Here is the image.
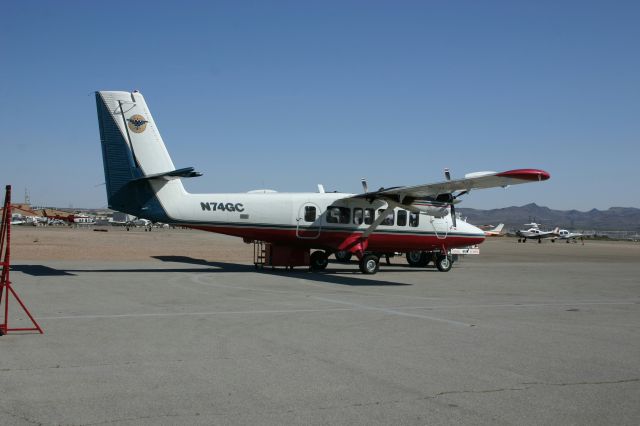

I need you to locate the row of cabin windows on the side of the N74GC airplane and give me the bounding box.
[304,206,420,228]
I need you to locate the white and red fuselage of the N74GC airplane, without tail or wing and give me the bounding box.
[149,181,485,252]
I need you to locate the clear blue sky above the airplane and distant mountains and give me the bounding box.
[0,0,640,210]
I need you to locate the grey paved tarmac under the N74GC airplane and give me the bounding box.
[0,241,640,425]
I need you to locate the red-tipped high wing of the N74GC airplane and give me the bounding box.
[353,169,550,203]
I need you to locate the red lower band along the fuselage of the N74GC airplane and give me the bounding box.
[186,225,485,252]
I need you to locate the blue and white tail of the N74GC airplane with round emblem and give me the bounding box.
[96,91,192,222]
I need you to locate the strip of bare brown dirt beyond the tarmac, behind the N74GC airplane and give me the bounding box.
[6,226,640,264]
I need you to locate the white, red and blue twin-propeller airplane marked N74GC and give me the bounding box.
[96,91,549,274]
